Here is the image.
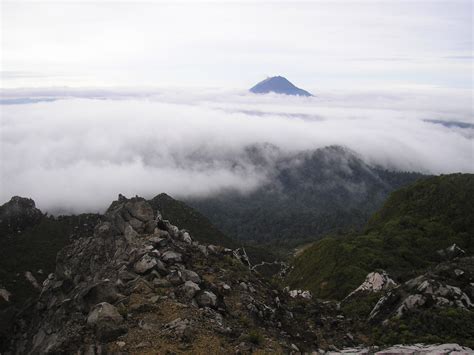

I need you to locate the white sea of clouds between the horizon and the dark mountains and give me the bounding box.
[0,88,474,212]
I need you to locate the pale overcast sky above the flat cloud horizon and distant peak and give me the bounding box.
[1,0,473,91]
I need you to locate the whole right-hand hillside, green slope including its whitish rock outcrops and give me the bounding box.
[286,174,474,351]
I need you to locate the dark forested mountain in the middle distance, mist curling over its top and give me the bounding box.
[184,146,422,245]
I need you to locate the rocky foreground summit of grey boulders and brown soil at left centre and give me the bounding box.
[7,196,356,354]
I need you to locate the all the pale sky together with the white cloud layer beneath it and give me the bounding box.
[0,0,474,212]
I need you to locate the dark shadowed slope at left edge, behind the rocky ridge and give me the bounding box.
[0,197,100,310]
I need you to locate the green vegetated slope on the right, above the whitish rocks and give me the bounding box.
[287,174,474,299]
